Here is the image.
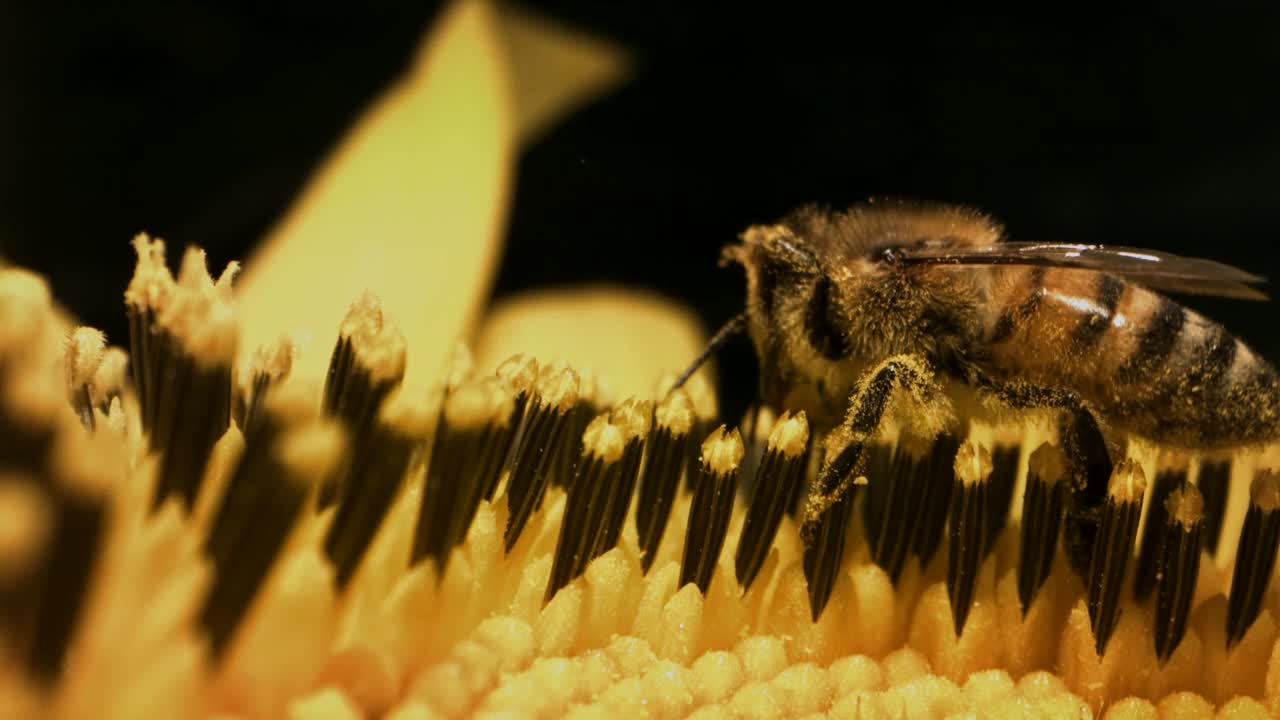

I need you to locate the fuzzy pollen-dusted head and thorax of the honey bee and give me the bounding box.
[722,204,992,415]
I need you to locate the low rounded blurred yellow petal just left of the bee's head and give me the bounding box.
[476,286,708,400]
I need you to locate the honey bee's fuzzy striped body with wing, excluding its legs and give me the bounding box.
[713,201,1280,450]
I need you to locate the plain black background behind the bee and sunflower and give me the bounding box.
[0,1,1280,420]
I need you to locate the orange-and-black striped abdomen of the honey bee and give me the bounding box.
[987,268,1280,448]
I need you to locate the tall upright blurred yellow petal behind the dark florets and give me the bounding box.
[239,0,515,386]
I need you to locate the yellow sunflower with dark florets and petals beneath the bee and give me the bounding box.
[0,0,1280,720]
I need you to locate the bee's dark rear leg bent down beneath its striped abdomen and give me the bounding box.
[980,380,1112,578]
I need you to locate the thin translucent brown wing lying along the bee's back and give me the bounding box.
[901,242,1267,300]
